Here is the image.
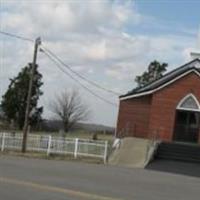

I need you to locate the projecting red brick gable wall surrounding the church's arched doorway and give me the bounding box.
[149,73,200,141]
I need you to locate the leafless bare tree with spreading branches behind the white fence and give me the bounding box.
[50,89,90,132]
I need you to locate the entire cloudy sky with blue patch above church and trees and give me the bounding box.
[0,0,200,126]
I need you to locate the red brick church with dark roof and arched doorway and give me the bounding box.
[117,59,200,143]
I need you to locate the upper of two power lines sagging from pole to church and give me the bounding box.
[43,46,120,96]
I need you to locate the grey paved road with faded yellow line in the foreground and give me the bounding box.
[0,156,200,200]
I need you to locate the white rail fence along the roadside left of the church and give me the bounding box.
[0,133,108,163]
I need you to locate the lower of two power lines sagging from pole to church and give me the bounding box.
[41,49,117,107]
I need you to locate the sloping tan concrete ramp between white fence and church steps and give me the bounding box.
[108,137,150,168]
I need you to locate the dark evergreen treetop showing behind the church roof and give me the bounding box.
[135,60,168,87]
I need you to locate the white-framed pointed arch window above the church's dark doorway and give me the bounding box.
[177,94,200,111]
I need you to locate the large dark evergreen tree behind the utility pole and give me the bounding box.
[1,64,43,129]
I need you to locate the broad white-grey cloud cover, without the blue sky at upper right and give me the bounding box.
[0,0,197,125]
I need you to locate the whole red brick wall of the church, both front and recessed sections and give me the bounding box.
[117,73,200,141]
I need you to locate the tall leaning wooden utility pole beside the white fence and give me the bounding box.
[22,37,41,153]
